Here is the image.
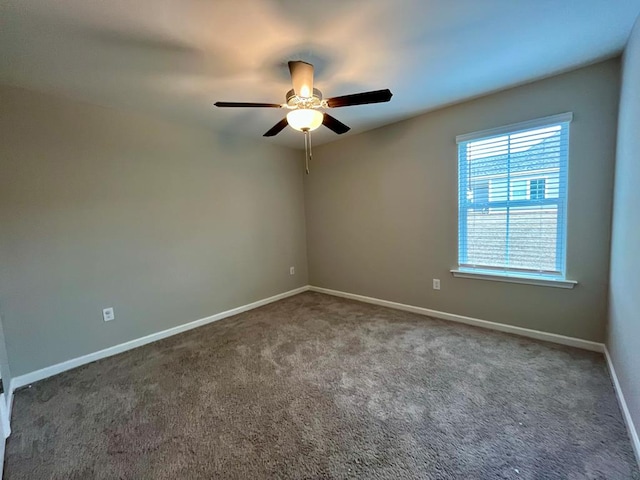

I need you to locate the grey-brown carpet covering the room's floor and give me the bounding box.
[5,293,640,480]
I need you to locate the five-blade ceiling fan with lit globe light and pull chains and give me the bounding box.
[214,61,393,173]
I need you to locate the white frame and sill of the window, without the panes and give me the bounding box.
[451,112,577,288]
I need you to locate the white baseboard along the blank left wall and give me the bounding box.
[9,285,309,396]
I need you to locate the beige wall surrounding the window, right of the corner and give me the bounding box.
[305,59,619,341]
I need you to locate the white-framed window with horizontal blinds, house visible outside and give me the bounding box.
[454,113,575,283]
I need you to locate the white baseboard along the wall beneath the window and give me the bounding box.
[309,286,604,353]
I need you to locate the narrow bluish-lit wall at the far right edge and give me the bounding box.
[607,19,640,454]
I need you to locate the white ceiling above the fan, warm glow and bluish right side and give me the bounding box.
[0,0,640,148]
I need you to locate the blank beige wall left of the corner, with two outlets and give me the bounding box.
[0,87,307,375]
